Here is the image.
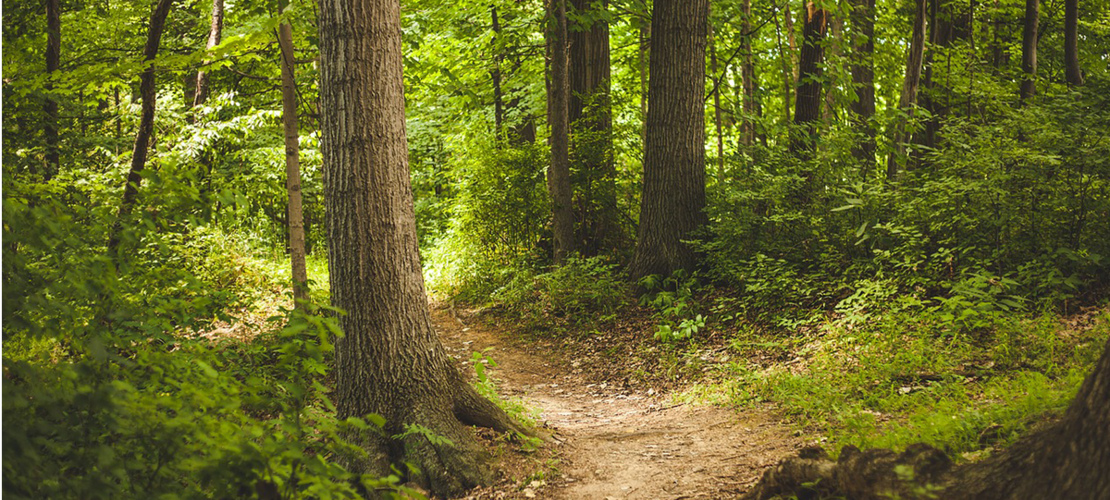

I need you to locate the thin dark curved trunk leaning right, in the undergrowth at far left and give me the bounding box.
[108,0,173,262]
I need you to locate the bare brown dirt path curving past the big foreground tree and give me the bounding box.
[433,308,800,500]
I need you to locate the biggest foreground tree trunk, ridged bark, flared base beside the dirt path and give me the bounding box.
[320,0,516,496]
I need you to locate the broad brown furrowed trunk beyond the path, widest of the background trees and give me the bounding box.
[628,0,709,279]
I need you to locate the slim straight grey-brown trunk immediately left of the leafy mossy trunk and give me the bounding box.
[547,0,575,264]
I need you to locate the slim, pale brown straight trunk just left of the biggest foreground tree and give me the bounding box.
[278,20,309,310]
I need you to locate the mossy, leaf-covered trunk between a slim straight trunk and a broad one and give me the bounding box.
[567,0,617,256]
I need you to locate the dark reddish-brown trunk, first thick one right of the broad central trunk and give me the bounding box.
[790,1,828,157]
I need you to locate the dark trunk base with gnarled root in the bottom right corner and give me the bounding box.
[744,342,1110,500]
